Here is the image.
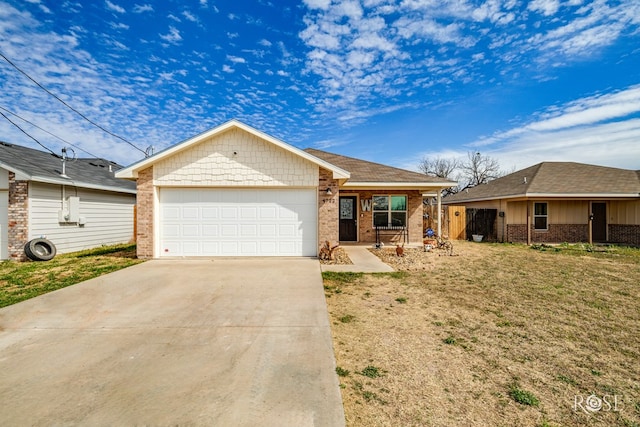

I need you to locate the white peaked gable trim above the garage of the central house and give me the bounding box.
[116,119,349,180]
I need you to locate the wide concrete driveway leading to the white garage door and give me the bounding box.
[0,258,344,426]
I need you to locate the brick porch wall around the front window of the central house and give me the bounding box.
[350,190,424,244]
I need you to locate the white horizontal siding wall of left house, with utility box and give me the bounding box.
[29,182,135,253]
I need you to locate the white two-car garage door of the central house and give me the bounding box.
[160,188,318,256]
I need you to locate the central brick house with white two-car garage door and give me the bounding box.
[116,120,456,258]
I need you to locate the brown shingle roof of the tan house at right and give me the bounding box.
[443,162,640,203]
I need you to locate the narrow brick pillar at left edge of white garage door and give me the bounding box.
[136,167,154,259]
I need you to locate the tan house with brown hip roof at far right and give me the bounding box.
[443,162,640,245]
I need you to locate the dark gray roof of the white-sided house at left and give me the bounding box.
[0,142,136,194]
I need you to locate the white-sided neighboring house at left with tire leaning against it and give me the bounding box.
[0,142,136,260]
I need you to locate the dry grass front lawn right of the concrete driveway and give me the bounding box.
[325,242,640,426]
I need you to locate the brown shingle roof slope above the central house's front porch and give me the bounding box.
[304,148,450,184]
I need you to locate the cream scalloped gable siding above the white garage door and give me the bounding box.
[153,129,318,187]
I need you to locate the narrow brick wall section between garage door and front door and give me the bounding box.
[318,168,339,245]
